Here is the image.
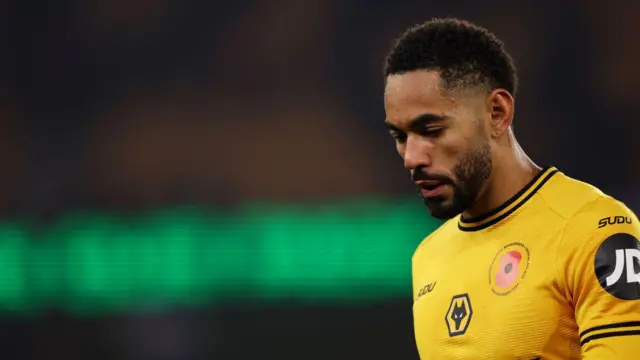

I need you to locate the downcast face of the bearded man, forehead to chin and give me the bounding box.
[384,70,492,219]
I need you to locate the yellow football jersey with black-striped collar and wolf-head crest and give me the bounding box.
[413,167,640,360]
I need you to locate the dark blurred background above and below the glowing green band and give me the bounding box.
[0,0,640,360]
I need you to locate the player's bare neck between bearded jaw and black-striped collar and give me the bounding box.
[462,138,541,219]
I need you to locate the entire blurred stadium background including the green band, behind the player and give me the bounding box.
[0,0,640,360]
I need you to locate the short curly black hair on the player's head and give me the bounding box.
[384,18,518,97]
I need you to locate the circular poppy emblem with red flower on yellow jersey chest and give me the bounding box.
[489,243,529,296]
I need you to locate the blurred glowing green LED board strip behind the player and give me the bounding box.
[0,200,439,312]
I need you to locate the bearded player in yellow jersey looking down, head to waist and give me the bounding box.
[384,19,640,360]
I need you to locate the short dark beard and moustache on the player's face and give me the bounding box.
[419,142,492,220]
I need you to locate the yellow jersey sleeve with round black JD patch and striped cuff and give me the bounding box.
[558,197,640,360]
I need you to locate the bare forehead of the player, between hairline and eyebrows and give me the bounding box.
[384,70,460,125]
